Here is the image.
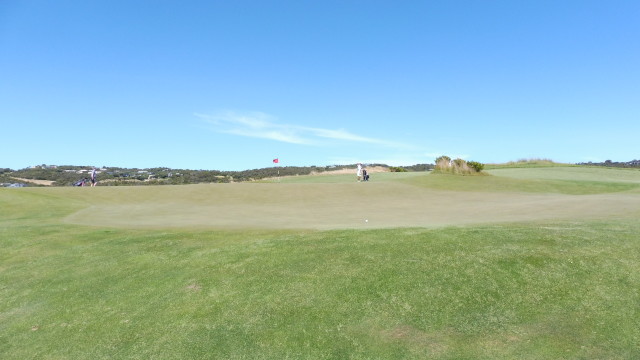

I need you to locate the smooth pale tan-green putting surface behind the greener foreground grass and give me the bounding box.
[58,168,640,230]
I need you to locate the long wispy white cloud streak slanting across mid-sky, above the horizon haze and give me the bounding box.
[195,111,408,148]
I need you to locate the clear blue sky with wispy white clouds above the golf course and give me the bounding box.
[0,0,640,170]
